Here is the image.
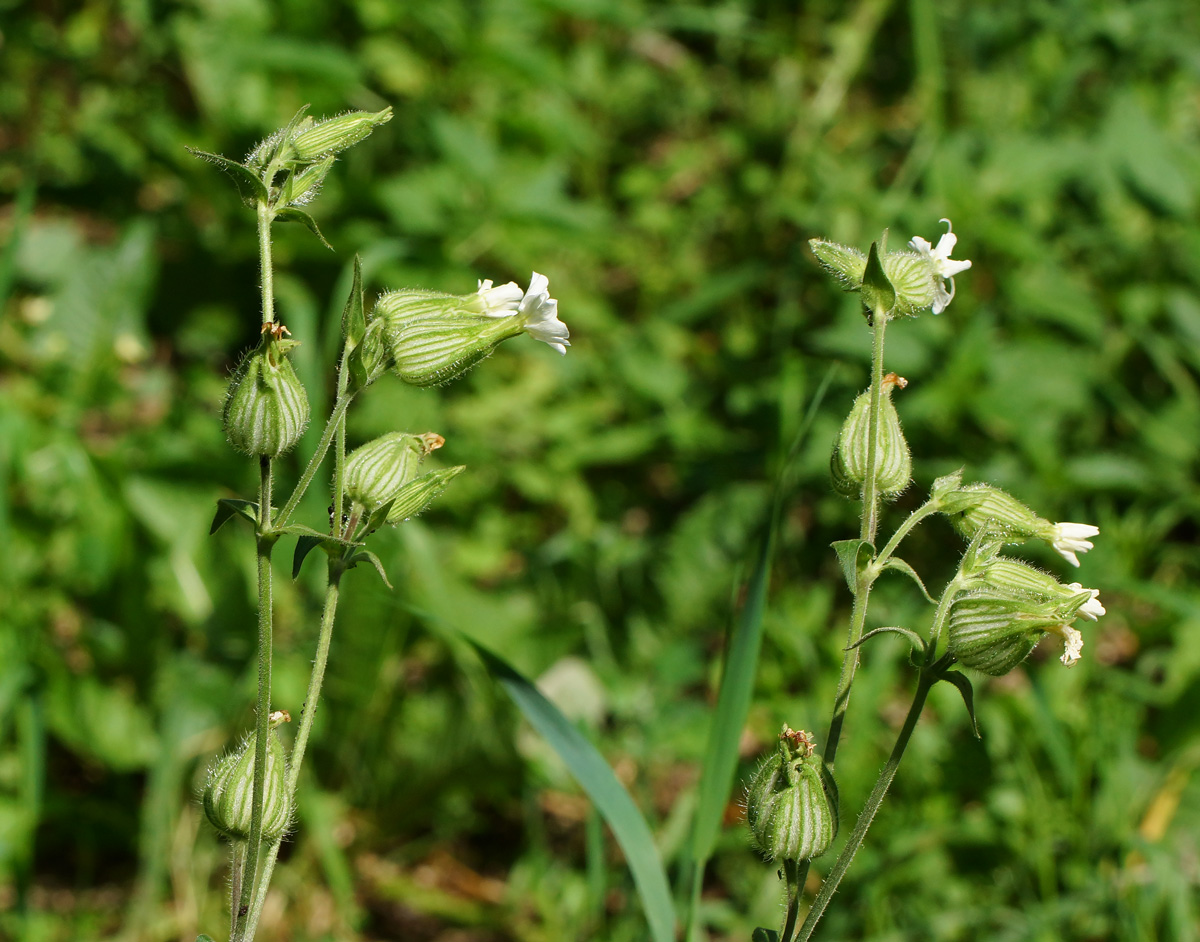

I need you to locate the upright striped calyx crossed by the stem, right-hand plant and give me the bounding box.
[829,373,912,498]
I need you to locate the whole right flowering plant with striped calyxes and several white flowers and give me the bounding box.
[746,220,1104,942]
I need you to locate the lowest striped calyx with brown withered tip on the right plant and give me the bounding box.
[746,725,838,860]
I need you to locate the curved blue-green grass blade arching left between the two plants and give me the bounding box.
[468,638,676,942]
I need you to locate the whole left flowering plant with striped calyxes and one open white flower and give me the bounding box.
[193,108,570,942]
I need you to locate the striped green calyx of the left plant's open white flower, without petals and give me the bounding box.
[374,286,524,386]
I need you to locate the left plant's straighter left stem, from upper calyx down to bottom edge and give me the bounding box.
[234,455,277,938]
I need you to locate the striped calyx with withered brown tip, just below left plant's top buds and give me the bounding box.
[221,325,308,458]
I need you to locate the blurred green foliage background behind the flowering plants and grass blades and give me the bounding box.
[0,0,1200,942]
